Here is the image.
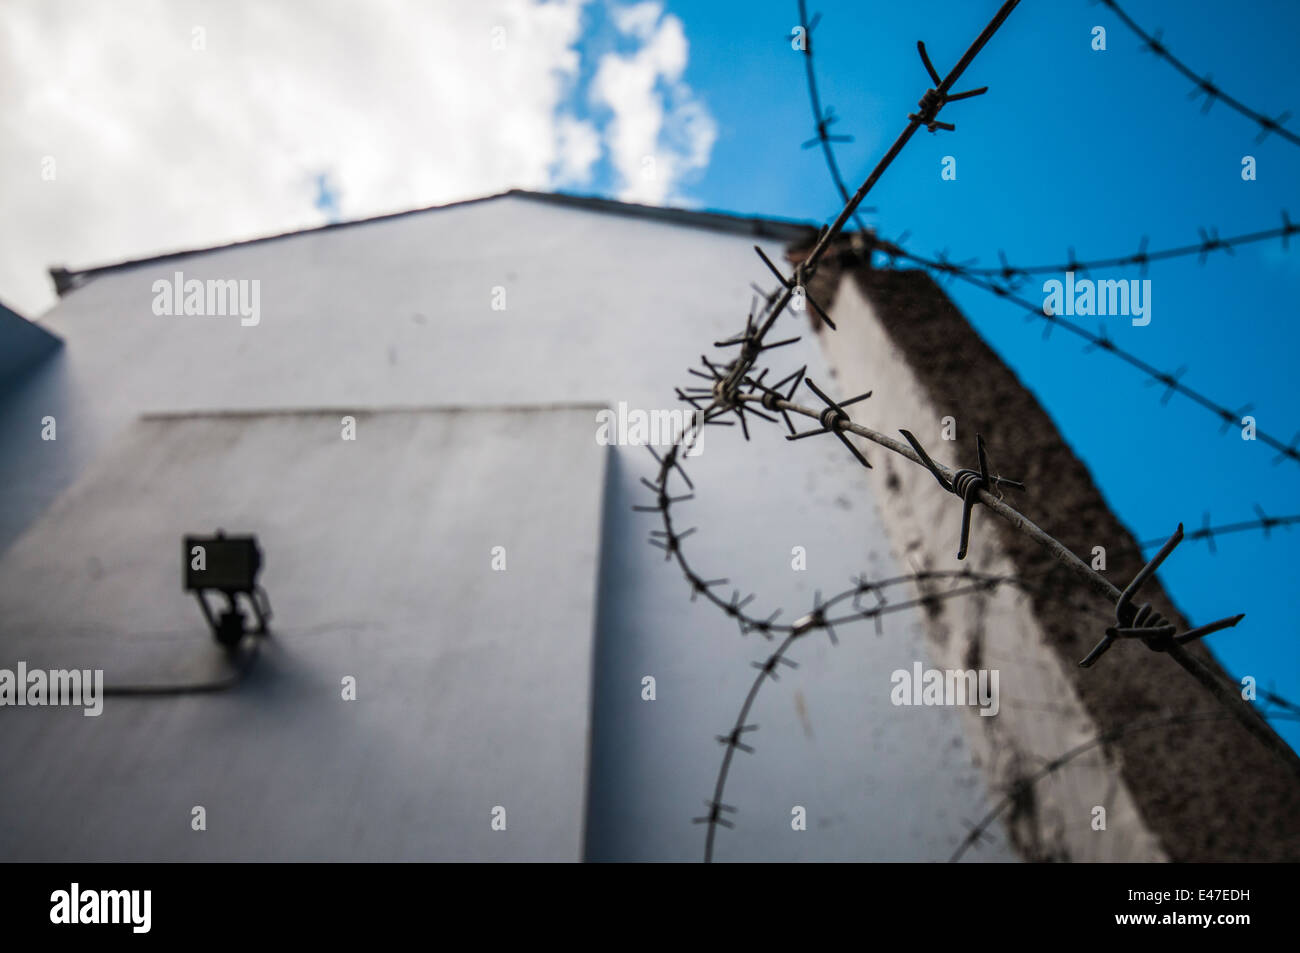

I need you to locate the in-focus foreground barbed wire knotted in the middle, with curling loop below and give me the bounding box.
[647,0,1300,844]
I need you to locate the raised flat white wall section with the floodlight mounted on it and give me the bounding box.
[0,408,605,861]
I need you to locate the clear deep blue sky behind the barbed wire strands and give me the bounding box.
[626,0,1300,746]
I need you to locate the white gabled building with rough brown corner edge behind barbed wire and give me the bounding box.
[0,191,1300,861]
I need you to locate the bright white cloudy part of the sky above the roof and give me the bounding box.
[0,0,715,317]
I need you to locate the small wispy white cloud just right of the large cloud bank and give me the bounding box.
[592,0,718,204]
